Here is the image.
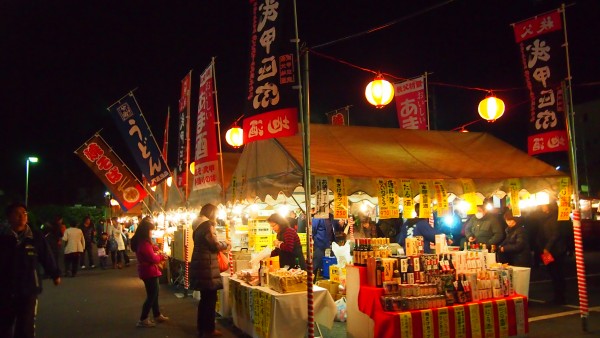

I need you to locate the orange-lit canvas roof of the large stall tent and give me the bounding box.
[226,124,566,199]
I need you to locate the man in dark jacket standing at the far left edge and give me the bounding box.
[0,203,60,338]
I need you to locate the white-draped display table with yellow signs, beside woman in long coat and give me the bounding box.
[223,277,336,338]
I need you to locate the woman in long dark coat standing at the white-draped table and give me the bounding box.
[190,204,231,337]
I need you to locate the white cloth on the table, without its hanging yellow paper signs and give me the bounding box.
[223,277,336,338]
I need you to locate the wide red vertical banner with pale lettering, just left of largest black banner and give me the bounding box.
[193,63,219,190]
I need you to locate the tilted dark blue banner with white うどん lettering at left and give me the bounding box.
[108,93,169,186]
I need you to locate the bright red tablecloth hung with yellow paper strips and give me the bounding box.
[358,268,529,338]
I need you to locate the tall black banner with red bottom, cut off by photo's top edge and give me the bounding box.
[243,0,298,144]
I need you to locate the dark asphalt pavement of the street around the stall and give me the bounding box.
[37,252,600,338]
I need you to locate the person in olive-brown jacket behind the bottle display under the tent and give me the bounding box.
[465,205,504,249]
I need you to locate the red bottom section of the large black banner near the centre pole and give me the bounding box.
[243,108,298,144]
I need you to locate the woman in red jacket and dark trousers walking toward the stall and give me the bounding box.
[131,217,169,327]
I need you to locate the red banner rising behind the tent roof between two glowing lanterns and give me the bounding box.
[394,76,429,130]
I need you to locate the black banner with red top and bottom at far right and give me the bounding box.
[513,10,569,155]
